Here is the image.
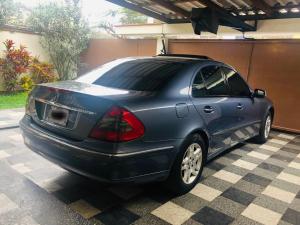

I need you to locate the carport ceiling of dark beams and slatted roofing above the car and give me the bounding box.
[107,0,300,23]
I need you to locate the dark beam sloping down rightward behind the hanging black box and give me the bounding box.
[197,0,256,31]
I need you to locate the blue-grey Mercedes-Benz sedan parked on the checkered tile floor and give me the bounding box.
[20,55,274,193]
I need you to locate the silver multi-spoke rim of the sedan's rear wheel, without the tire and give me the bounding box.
[181,143,202,184]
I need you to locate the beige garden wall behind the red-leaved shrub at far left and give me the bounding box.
[0,30,49,91]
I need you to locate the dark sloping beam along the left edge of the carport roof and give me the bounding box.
[106,0,171,23]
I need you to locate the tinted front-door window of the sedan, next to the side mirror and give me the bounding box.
[222,67,250,97]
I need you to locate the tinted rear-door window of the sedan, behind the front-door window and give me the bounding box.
[201,66,229,96]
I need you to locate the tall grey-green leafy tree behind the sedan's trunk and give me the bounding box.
[28,0,90,80]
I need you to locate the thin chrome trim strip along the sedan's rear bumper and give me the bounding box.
[20,121,174,158]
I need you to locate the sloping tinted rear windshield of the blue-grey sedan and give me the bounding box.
[77,59,185,91]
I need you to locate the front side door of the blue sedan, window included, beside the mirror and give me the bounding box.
[222,66,260,144]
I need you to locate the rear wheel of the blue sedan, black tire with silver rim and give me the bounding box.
[165,134,206,195]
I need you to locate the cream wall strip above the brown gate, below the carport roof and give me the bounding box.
[115,18,300,39]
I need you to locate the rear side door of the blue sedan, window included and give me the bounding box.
[192,64,236,154]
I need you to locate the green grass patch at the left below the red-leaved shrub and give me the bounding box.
[0,92,27,109]
